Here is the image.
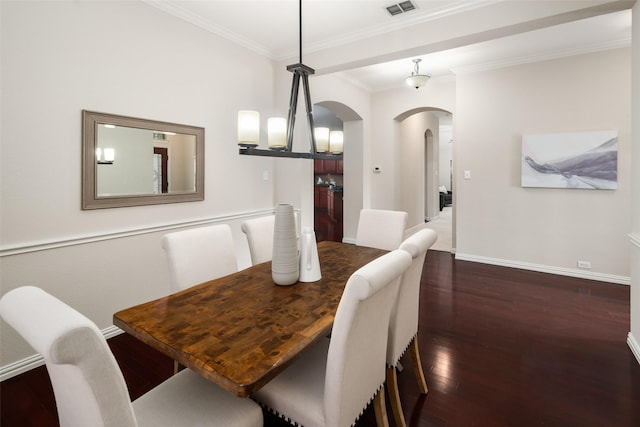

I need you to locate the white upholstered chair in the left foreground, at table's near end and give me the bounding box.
[0,286,263,427]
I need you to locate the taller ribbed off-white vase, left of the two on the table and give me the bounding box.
[271,204,300,286]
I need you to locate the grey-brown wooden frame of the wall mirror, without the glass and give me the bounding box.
[82,110,204,210]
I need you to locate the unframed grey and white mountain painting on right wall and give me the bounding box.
[521,130,618,190]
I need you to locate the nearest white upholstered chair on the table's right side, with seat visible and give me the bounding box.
[253,250,411,427]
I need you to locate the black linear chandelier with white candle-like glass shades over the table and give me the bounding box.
[238,0,342,159]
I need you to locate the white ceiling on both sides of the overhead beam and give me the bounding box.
[148,0,631,91]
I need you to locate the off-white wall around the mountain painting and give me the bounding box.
[454,48,631,282]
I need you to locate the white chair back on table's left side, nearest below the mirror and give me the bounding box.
[160,224,238,292]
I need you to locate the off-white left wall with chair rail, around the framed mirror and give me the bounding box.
[0,1,274,366]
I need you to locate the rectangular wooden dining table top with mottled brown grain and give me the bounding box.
[113,241,387,397]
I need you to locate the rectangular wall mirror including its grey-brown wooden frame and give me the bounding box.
[82,110,204,209]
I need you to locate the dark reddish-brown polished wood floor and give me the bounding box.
[0,251,640,427]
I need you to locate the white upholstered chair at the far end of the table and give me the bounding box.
[356,209,409,251]
